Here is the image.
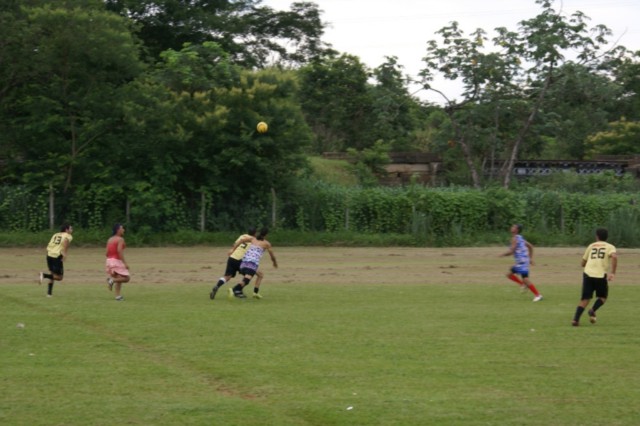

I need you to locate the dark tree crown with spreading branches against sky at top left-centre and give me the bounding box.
[105,0,326,67]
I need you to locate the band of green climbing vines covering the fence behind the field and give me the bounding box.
[0,181,640,243]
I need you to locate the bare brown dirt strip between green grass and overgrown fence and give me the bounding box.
[0,246,640,285]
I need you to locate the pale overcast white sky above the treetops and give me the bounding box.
[262,0,640,103]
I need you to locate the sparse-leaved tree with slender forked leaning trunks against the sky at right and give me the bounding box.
[421,0,624,187]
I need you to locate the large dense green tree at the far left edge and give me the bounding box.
[0,2,143,192]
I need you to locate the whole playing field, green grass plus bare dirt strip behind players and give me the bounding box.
[0,246,640,426]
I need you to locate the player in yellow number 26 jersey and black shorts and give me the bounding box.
[571,228,618,327]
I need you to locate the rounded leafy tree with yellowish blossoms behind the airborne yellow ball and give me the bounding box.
[118,43,311,227]
